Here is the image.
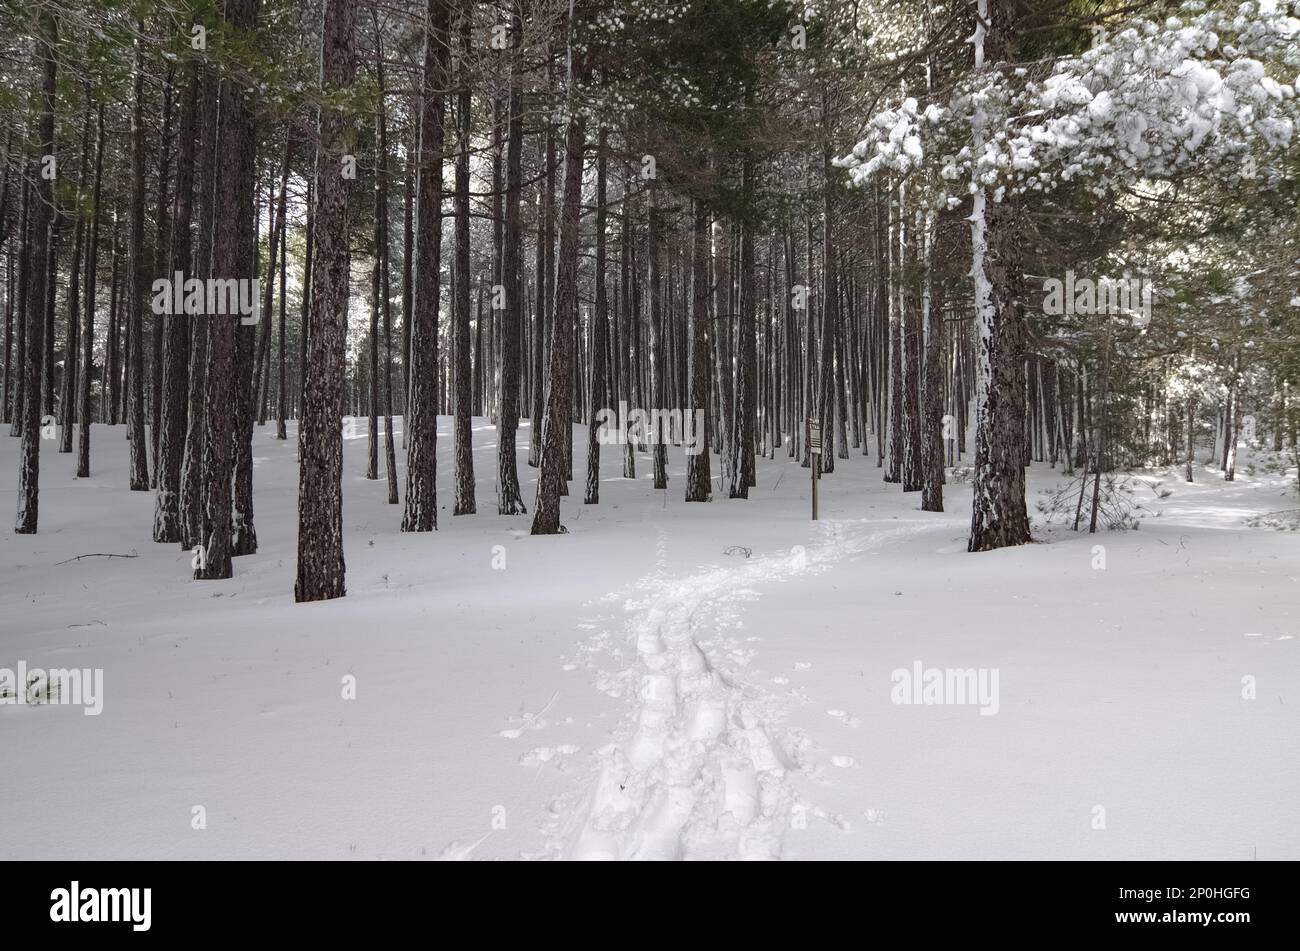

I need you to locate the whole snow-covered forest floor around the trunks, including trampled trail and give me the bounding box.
[0,417,1300,859]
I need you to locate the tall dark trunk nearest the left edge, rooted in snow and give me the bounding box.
[13,6,59,535]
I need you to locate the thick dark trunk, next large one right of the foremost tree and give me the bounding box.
[402,0,451,531]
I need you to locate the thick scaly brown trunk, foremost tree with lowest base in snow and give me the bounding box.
[294,0,356,602]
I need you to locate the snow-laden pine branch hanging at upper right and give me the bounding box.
[836,0,1300,207]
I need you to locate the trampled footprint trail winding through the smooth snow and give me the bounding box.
[551,518,935,859]
